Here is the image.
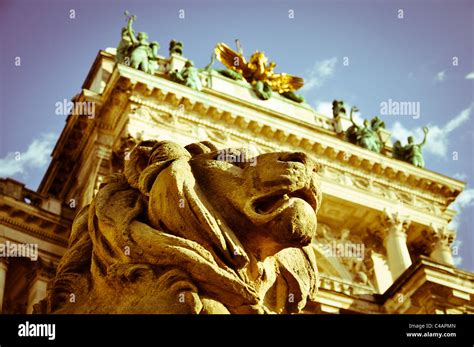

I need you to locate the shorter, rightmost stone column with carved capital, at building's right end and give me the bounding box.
[426,225,456,266]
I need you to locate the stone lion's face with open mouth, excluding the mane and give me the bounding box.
[190,145,321,260]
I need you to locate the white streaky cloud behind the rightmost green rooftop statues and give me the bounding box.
[390,104,474,157]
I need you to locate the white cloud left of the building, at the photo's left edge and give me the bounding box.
[0,133,57,178]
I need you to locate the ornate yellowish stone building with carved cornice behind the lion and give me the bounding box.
[0,45,474,313]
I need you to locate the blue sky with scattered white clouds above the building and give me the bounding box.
[0,0,474,271]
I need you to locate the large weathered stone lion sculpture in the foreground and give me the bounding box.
[36,141,321,314]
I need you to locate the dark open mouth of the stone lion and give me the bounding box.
[253,188,317,214]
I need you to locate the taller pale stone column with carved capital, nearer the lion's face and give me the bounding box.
[382,211,411,281]
